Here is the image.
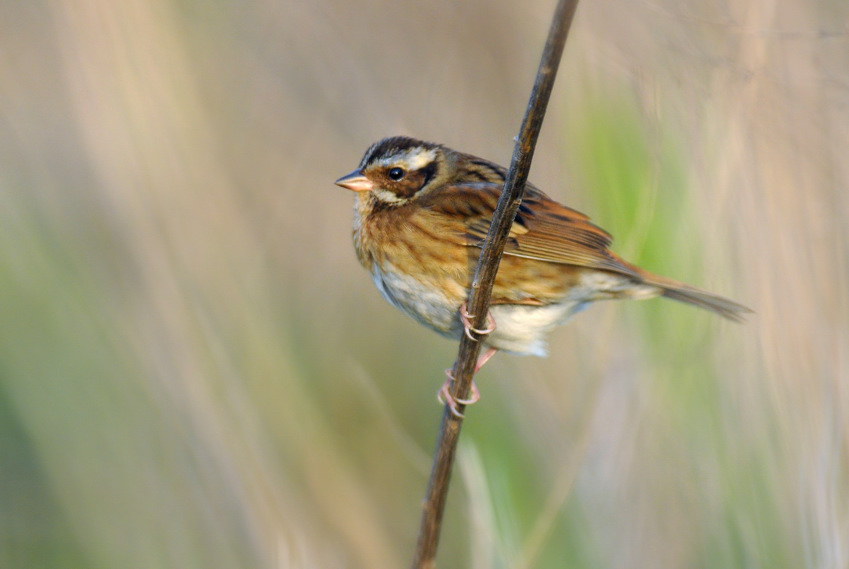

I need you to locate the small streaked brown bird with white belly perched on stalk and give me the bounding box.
[336,136,749,412]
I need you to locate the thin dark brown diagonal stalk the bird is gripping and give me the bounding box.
[413,0,578,569]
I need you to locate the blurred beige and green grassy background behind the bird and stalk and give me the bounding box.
[0,0,849,569]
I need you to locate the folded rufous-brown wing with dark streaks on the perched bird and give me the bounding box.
[420,182,639,278]
